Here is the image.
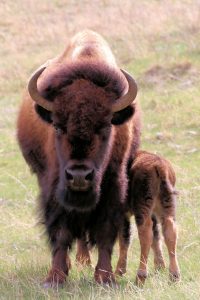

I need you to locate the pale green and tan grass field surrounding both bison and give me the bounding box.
[0,0,200,300]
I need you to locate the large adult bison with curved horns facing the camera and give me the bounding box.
[17,31,140,286]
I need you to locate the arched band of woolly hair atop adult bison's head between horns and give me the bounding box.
[39,59,126,101]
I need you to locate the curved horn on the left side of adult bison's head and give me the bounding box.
[28,60,53,111]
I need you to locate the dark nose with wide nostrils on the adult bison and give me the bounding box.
[65,169,94,191]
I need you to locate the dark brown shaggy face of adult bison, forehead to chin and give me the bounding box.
[53,91,114,211]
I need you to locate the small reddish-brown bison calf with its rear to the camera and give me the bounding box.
[129,151,180,284]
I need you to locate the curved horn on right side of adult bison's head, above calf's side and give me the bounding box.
[112,69,137,112]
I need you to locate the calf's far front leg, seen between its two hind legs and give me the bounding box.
[151,215,165,270]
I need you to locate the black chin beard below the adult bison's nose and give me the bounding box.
[56,188,99,212]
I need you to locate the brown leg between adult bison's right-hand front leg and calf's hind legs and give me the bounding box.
[115,218,130,276]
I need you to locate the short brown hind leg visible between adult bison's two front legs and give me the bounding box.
[76,236,91,266]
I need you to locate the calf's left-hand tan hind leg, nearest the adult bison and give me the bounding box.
[135,215,153,285]
